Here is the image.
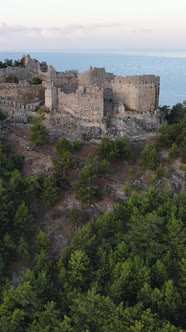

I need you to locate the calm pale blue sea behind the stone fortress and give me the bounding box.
[0,49,186,107]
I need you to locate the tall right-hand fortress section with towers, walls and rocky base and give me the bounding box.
[45,68,160,136]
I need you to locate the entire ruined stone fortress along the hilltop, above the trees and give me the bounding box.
[0,55,161,138]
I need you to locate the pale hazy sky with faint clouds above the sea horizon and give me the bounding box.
[0,0,186,50]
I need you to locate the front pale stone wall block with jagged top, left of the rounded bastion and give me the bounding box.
[58,87,104,126]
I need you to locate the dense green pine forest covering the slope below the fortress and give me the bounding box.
[0,103,186,332]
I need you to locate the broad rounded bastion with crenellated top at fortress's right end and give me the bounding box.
[110,75,159,112]
